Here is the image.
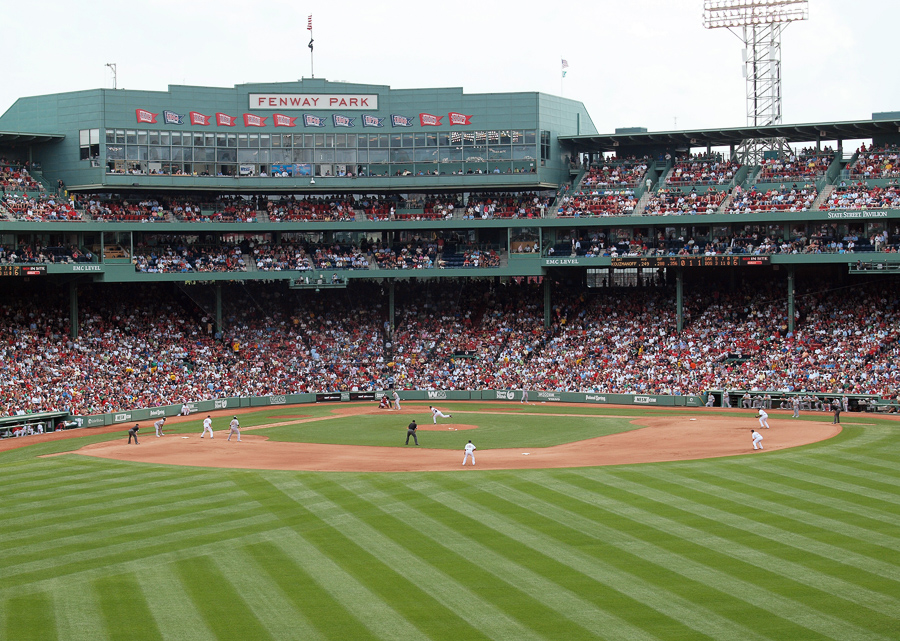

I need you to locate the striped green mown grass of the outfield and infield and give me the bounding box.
[0,403,900,641]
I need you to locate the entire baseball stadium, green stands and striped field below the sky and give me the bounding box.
[0,12,900,641]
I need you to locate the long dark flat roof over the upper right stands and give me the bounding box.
[559,118,900,152]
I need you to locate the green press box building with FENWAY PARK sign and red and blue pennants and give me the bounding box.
[0,79,596,193]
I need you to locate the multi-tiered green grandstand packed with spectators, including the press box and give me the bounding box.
[0,80,900,424]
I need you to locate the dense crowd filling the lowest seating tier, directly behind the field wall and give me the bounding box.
[0,281,900,415]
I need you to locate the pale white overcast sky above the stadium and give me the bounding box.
[0,0,900,133]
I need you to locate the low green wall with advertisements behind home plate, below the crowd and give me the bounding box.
[69,390,703,427]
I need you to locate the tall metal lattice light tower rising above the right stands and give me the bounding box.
[703,0,809,164]
